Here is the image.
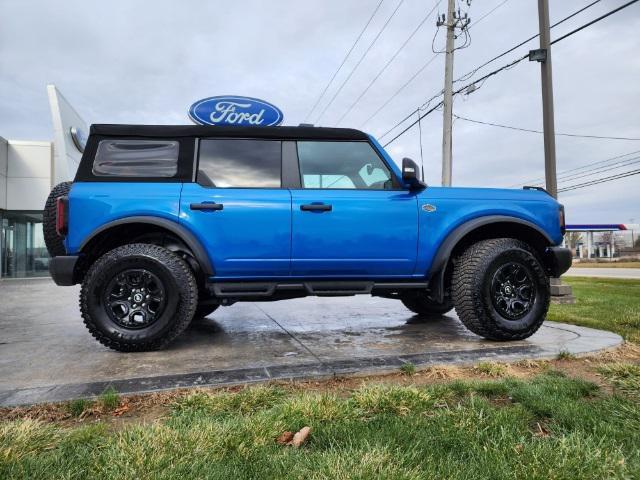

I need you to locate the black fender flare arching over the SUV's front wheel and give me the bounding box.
[429,215,553,302]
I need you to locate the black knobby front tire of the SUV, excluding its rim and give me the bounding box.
[451,238,550,340]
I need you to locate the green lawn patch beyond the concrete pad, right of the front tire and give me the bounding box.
[547,277,640,343]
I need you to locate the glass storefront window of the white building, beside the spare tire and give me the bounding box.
[0,211,49,278]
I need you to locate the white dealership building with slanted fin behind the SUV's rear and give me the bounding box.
[0,85,88,278]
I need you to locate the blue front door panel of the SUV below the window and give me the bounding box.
[291,189,418,278]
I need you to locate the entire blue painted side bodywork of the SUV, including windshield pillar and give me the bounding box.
[66,133,562,280]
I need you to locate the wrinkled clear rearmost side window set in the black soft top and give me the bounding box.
[92,140,180,178]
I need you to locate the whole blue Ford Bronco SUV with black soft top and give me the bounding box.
[44,125,571,351]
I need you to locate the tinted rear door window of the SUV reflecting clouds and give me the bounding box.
[198,139,282,188]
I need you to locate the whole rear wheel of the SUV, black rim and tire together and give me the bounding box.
[80,243,198,352]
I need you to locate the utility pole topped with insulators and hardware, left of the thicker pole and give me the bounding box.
[436,0,471,187]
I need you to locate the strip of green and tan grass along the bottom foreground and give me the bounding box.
[0,376,640,480]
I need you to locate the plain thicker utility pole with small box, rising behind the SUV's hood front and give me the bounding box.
[538,0,558,198]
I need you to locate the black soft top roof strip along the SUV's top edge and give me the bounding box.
[90,124,368,140]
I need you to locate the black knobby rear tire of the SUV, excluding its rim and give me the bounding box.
[80,243,198,352]
